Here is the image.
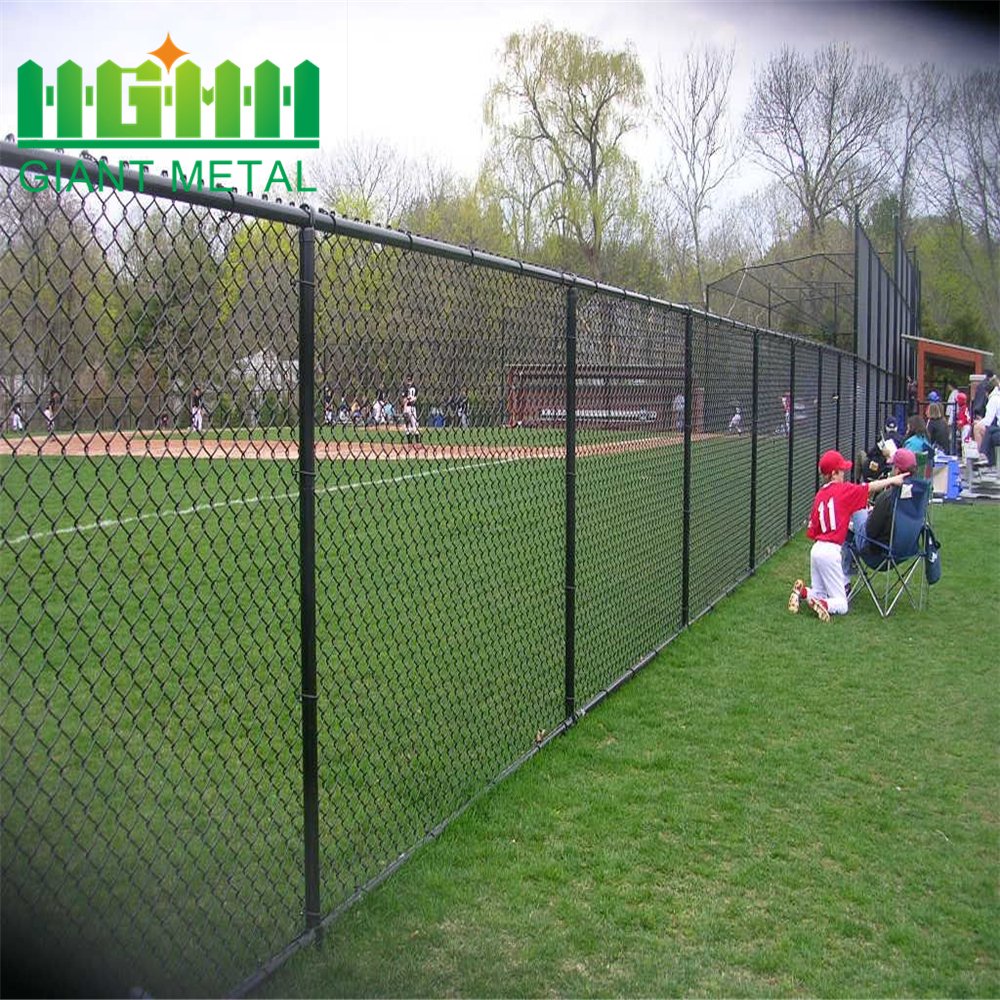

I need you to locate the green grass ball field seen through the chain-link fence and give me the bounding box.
[0,432,884,995]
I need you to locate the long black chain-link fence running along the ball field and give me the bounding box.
[0,144,908,996]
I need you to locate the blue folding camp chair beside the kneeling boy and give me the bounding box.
[847,479,933,618]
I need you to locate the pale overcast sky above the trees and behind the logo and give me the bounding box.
[0,0,1000,199]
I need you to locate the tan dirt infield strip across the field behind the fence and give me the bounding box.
[0,431,716,461]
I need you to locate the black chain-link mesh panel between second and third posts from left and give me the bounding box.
[576,294,684,705]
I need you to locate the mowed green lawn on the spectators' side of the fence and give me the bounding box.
[261,504,1000,997]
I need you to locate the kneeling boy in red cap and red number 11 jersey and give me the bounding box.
[788,450,908,622]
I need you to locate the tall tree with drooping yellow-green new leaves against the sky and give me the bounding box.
[484,25,644,279]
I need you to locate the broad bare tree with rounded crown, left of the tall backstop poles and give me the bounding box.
[744,44,897,250]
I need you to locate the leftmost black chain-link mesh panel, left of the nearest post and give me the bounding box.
[0,172,301,994]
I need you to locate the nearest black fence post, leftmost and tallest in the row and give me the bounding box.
[299,227,321,930]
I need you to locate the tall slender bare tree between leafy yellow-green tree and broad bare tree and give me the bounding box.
[654,47,736,302]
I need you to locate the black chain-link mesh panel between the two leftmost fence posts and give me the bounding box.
[308,237,565,907]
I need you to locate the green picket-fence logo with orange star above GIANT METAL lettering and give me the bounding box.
[17,34,319,149]
